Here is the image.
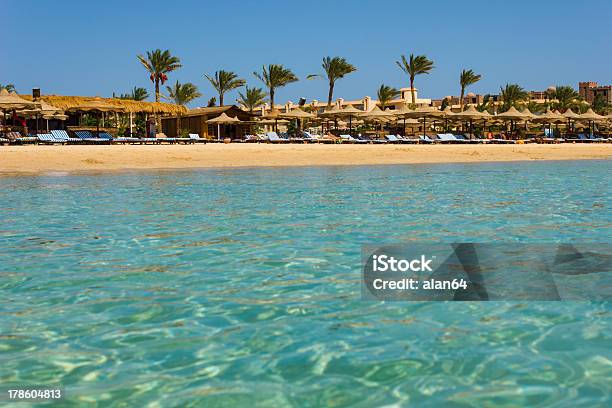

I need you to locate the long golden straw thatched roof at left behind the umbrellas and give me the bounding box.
[20,95,187,115]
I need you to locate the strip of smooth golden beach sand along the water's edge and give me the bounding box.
[0,143,612,175]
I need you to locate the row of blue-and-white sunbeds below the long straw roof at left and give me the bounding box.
[0,130,206,144]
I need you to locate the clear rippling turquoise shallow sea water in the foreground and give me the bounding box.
[0,161,612,407]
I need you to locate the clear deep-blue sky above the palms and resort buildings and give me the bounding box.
[0,0,612,106]
